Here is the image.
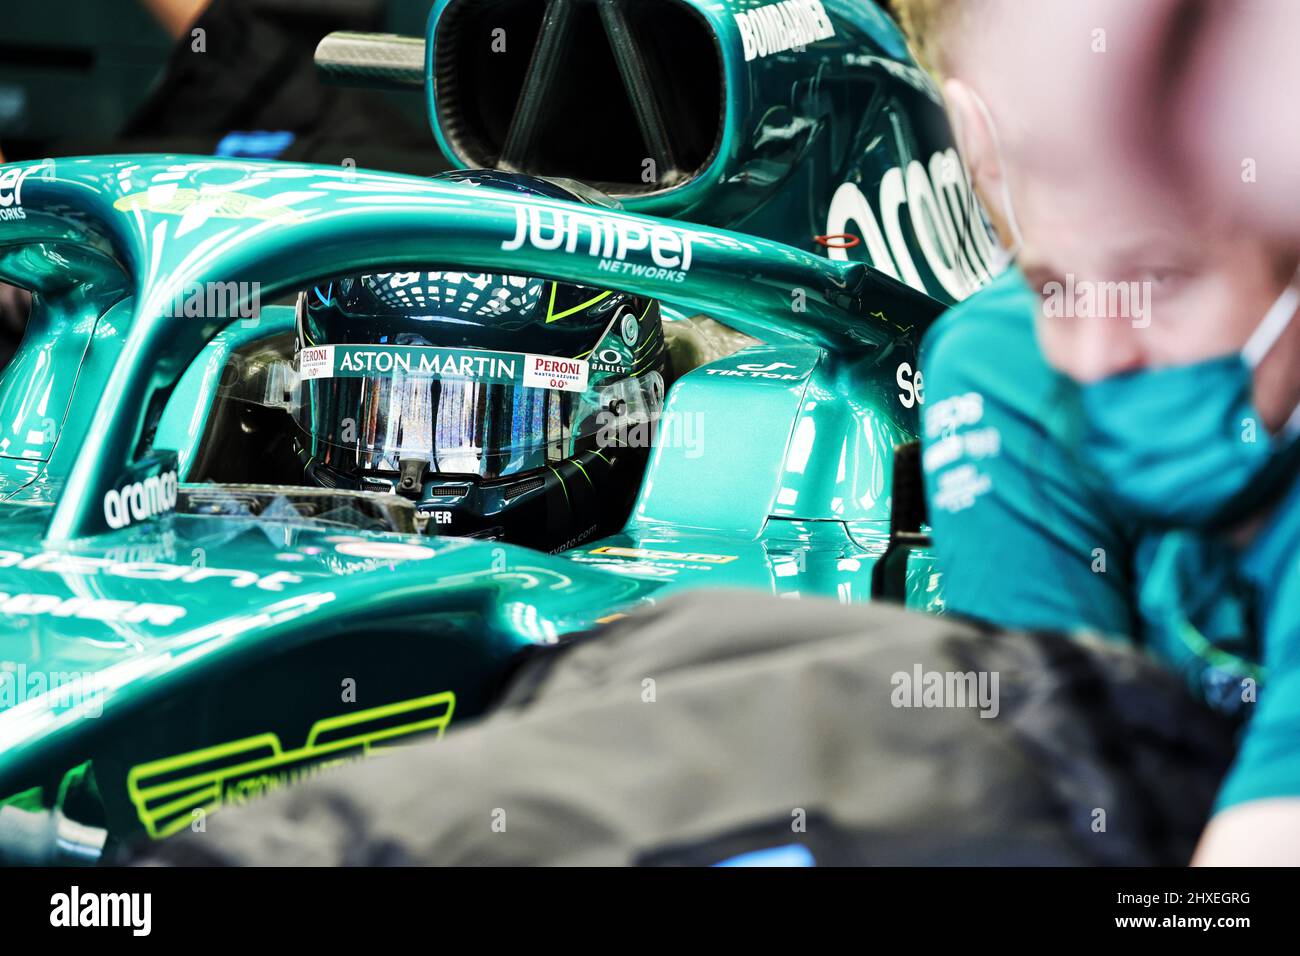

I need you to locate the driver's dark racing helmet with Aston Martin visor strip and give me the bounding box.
[294,170,664,550]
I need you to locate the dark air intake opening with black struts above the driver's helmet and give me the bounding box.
[430,0,727,195]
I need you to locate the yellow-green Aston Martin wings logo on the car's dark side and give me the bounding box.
[126,691,456,840]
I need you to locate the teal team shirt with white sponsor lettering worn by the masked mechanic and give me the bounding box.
[920,269,1300,806]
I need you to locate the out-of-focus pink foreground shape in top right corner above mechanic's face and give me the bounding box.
[978,0,1300,248]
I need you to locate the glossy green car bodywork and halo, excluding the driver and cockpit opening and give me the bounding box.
[0,0,991,856]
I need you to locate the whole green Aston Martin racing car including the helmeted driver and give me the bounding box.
[0,0,993,862]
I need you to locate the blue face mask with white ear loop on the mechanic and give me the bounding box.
[1079,280,1300,528]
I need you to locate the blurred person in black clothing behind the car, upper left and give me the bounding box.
[74,0,447,169]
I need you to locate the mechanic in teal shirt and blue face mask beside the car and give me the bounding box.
[898,0,1300,864]
